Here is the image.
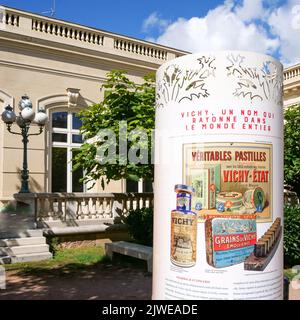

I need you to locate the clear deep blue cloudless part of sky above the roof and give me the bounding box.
[0,0,222,38]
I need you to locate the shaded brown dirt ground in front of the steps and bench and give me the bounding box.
[0,250,152,300]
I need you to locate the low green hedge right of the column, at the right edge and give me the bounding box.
[284,205,300,267]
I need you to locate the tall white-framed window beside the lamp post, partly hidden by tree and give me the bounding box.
[50,111,84,192]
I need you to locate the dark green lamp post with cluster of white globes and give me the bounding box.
[1,95,48,193]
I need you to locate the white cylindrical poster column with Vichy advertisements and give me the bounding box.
[153,51,283,299]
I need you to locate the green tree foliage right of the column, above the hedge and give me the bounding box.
[284,105,300,195]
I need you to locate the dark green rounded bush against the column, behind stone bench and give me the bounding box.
[125,208,153,246]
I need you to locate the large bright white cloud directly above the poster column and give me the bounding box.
[156,1,279,53]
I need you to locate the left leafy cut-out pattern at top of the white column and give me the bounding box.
[156,56,216,107]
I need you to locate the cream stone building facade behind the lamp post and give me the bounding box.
[0,7,185,205]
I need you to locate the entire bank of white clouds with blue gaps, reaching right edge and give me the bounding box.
[144,0,300,64]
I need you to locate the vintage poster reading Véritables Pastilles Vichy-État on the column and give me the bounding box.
[183,143,272,222]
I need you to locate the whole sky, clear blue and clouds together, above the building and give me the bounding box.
[0,0,300,65]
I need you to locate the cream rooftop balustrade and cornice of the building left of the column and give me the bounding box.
[0,6,187,69]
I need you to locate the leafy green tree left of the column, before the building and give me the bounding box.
[74,70,155,189]
